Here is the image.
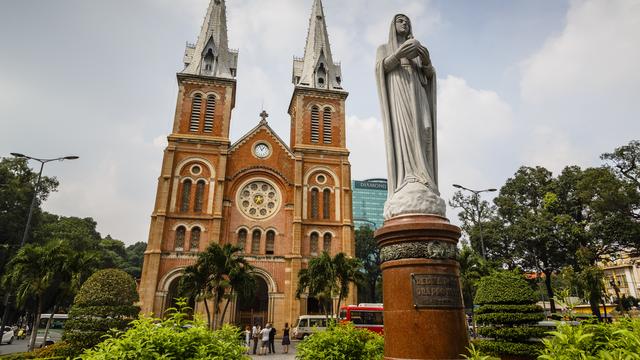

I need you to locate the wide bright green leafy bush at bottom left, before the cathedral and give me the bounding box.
[80,302,249,360]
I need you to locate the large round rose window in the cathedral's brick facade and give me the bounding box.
[238,180,280,219]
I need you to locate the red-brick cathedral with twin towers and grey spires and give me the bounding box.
[139,0,356,328]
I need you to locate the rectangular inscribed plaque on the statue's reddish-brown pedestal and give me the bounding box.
[411,274,463,308]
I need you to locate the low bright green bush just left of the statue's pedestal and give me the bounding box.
[296,324,384,360]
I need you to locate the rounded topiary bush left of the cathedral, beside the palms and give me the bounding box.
[62,269,140,354]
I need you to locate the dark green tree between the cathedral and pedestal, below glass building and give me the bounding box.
[355,226,382,303]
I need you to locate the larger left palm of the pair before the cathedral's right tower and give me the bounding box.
[296,251,338,316]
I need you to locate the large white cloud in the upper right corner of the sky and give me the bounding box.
[521,0,640,104]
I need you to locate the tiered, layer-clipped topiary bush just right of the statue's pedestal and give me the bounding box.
[474,271,547,359]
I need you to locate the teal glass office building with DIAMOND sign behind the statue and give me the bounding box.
[351,179,387,229]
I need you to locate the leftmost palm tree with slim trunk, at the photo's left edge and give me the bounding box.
[3,241,66,350]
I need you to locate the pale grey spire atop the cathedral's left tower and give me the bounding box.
[182,0,238,78]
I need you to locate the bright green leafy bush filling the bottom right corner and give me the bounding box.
[538,319,640,360]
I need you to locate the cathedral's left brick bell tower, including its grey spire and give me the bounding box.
[140,0,238,315]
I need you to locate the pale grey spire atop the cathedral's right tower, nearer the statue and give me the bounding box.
[292,0,342,90]
